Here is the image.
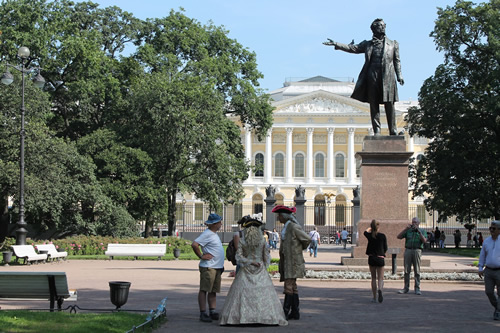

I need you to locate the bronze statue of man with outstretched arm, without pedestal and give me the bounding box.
[323,19,404,135]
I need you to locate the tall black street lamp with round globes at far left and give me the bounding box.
[1,46,45,245]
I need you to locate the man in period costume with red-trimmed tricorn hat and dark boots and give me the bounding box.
[272,205,311,320]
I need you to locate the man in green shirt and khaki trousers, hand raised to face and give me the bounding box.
[397,217,427,295]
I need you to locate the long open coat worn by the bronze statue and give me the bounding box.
[335,37,402,104]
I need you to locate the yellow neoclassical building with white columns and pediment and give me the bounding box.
[177,76,427,230]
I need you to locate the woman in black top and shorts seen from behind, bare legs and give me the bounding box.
[364,220,387,303]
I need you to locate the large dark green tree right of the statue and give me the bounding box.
[408,0,500,221]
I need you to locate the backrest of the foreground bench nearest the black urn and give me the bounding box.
[0,272,70,299]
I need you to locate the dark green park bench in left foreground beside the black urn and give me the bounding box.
[0,272,77,312]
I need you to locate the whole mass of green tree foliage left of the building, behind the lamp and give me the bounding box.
[0,0,272,238]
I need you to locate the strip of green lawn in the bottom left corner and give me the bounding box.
[0,310,152,333]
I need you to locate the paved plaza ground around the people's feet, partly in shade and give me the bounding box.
[0,245,500,333]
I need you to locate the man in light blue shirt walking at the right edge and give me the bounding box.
[478,221,500,320]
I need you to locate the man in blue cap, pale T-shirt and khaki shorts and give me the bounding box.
[191,213,225,322]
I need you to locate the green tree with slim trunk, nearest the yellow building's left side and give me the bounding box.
[125,11,272,234]
